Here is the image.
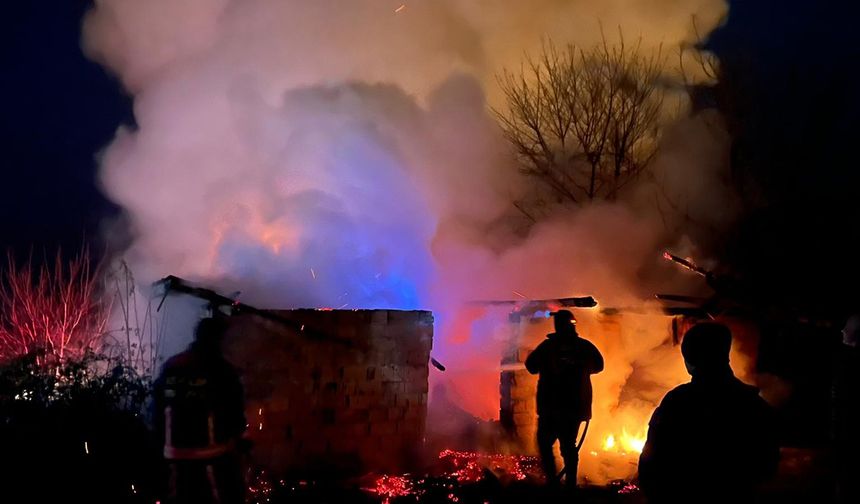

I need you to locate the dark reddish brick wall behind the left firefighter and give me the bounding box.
[225,310,433,475]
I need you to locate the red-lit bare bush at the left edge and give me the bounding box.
[0,252,166,375]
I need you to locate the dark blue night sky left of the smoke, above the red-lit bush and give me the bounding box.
[0,0,132,255]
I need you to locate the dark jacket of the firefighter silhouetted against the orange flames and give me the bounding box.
[526,333,603,421]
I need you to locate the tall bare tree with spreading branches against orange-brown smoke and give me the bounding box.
[494,33,663,211]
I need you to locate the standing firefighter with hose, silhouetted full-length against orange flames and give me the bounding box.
[525,310,603,488]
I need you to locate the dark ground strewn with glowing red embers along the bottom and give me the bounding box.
[242,450,832,504]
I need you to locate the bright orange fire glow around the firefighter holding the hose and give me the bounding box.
[494,310,690,485]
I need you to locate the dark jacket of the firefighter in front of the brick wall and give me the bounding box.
[154,343,246,458]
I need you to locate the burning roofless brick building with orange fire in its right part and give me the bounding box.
[175,258,758,483]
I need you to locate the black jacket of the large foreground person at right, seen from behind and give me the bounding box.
[639,367,779,503]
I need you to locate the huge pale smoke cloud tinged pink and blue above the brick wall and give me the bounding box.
[84,0,725,300]
